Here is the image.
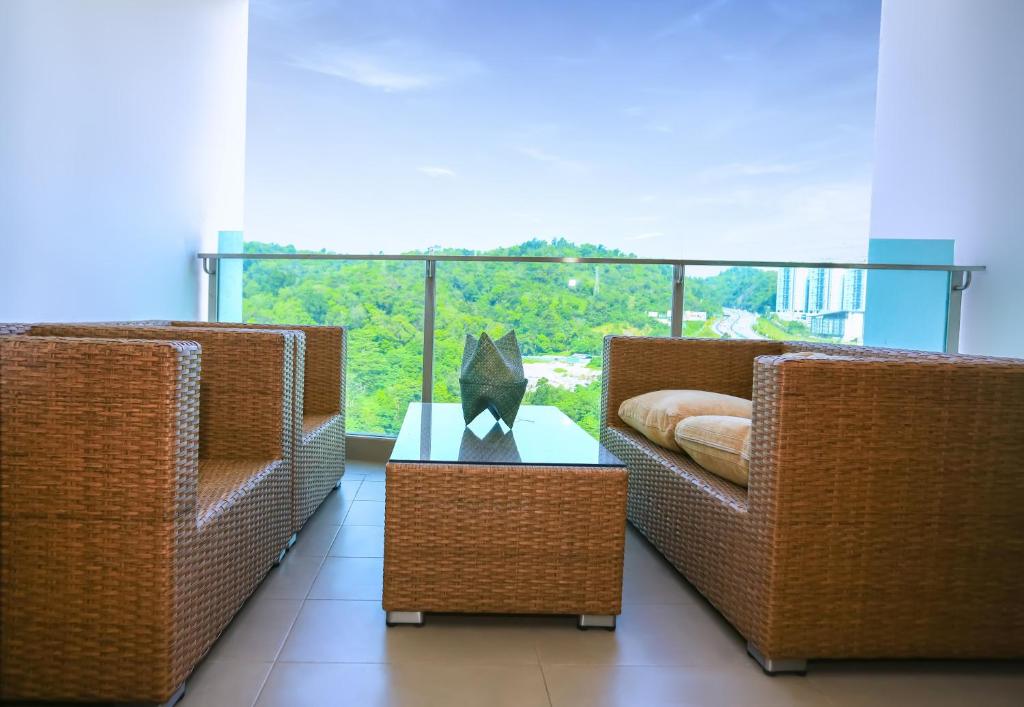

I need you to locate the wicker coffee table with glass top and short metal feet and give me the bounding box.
[383,403,627,629]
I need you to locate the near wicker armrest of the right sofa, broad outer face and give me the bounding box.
[748,357,1024,656]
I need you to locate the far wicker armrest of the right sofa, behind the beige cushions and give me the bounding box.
[601,336,782,428]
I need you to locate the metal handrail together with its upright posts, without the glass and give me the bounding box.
[197,252,985,424]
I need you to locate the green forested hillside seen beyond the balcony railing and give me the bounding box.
[243,239,776,434]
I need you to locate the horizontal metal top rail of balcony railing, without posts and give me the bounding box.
[197,248,985,273]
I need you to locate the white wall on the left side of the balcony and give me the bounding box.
[0,0,249,321]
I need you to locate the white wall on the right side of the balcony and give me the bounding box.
[870,0,1024,357]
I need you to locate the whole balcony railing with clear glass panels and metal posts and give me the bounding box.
[199,247,985,435]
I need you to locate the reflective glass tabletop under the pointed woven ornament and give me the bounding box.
[391,403,625,466]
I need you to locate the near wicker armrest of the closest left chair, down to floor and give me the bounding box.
[0,336,202,700]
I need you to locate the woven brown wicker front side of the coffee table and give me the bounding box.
[384,463,627,614]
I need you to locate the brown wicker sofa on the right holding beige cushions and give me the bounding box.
[601,336,1024,672]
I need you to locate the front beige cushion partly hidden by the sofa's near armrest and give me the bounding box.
[675,415,751,486]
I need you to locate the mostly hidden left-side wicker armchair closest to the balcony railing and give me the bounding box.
[110,320,347,541]
